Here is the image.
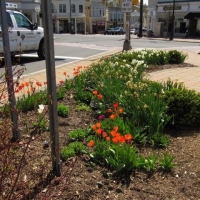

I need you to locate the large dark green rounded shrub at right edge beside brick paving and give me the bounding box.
[163,88,200,127]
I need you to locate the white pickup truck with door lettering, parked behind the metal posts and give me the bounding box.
[0,10,45,60]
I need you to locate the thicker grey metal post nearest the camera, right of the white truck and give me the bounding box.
[41,0,61,176]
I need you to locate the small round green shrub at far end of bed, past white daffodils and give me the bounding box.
[168,50,187,64]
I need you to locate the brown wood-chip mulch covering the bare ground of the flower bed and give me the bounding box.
[2,64,200,200]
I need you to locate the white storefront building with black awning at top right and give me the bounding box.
[147,0,200,37]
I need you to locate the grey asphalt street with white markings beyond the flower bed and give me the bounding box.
[0,34,200,75]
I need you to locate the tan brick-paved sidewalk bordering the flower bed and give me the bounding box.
[15,38,200,95]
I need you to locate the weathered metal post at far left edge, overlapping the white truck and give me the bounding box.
[0,0,20,141]
